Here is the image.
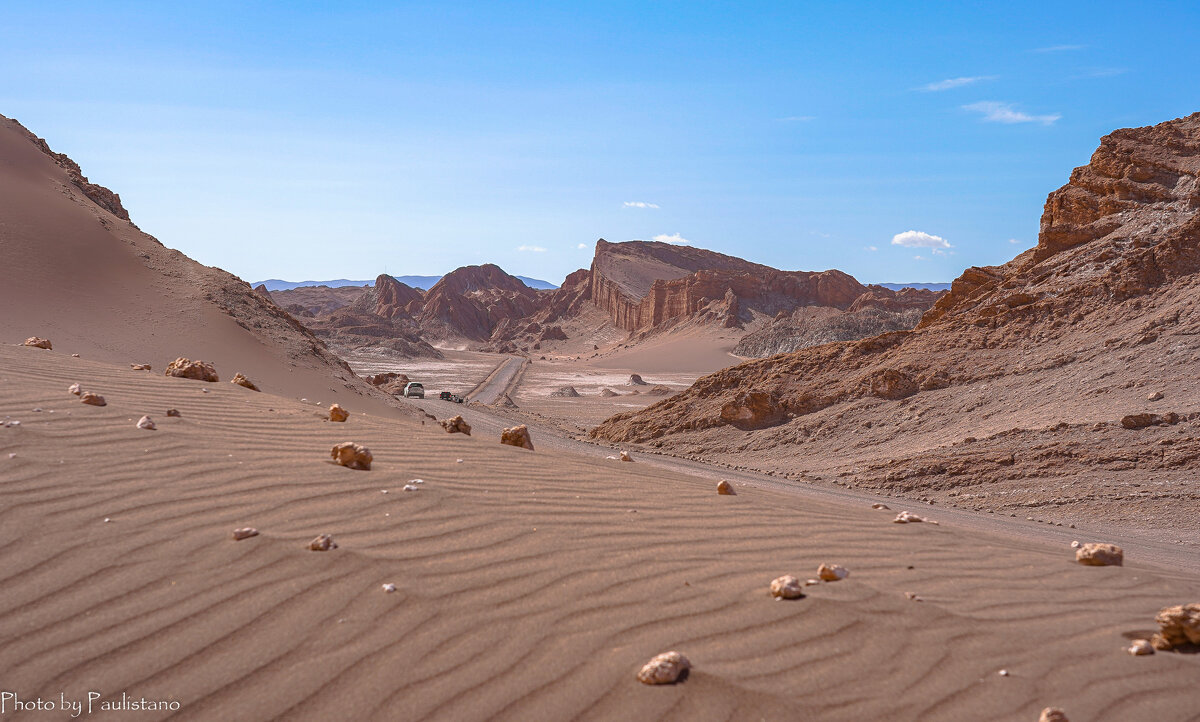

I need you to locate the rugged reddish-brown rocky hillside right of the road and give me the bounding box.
[593,114,1200,527]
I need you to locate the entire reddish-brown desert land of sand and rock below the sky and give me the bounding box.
[0,106,1200,722]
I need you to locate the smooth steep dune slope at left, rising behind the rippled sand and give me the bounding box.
[0,116,403,414]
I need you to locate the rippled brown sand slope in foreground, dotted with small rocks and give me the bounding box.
[0,347,1200,722]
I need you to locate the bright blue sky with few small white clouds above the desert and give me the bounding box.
[0,1,1200,283]
